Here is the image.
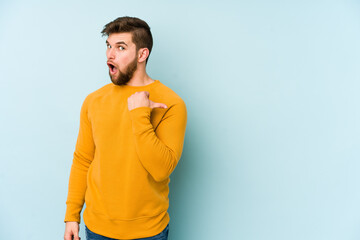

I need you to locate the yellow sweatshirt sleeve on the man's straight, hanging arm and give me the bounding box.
[64,98,95,223]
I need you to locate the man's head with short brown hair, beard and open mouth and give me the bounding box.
[101,17,153,85]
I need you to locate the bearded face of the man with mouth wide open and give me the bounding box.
[106,33,137,86]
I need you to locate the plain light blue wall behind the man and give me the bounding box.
[0,0,360,240]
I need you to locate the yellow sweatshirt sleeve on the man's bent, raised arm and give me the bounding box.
[129,100,187,181]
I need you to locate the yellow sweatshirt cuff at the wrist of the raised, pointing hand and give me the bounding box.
[129,107,153,134]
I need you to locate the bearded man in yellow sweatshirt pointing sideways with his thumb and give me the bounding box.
[64,17,187,240]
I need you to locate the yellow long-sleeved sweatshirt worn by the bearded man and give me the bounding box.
[64,80,187,239]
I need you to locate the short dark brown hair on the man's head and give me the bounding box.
[101,16,153,63]
